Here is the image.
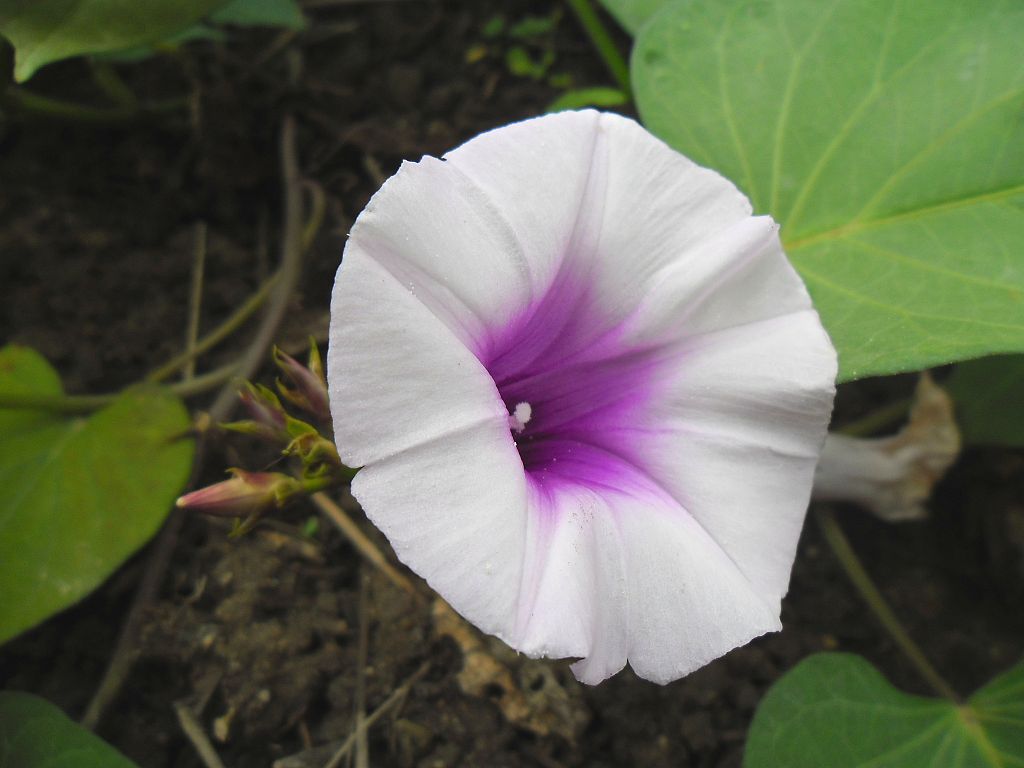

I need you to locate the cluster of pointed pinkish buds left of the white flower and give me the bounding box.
[177,342,354,535]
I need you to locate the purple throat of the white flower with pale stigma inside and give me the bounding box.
[481,274,656,490]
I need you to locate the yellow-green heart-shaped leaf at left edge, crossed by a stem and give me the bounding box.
[0,346,193,642]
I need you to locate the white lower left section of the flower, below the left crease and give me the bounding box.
[352,423,526,642]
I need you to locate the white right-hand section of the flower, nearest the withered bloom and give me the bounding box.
[641,309,836,613]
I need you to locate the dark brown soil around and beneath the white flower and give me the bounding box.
[0,0,1024,768]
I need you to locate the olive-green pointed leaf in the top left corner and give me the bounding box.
[0,0,226,82]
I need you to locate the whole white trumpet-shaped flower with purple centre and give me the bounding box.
[328,111,837,684]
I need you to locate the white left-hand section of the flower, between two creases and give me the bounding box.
[328,249,511,467]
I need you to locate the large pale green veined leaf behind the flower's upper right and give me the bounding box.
[633,0,1024,379]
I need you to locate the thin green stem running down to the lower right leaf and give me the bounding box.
[815,507,962,706]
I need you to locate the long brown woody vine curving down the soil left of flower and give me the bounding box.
[82,115,311,729]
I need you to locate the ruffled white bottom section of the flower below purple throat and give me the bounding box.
[515,484,780,685]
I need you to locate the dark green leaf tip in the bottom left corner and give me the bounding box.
[0,691,137,768]
